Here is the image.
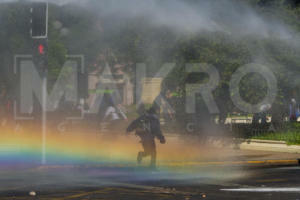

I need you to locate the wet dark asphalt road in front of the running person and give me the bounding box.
[0,166,300,200]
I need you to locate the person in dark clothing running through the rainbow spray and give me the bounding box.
[127,107,166,168]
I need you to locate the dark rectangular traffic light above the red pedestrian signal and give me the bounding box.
[30,2,48,39]
